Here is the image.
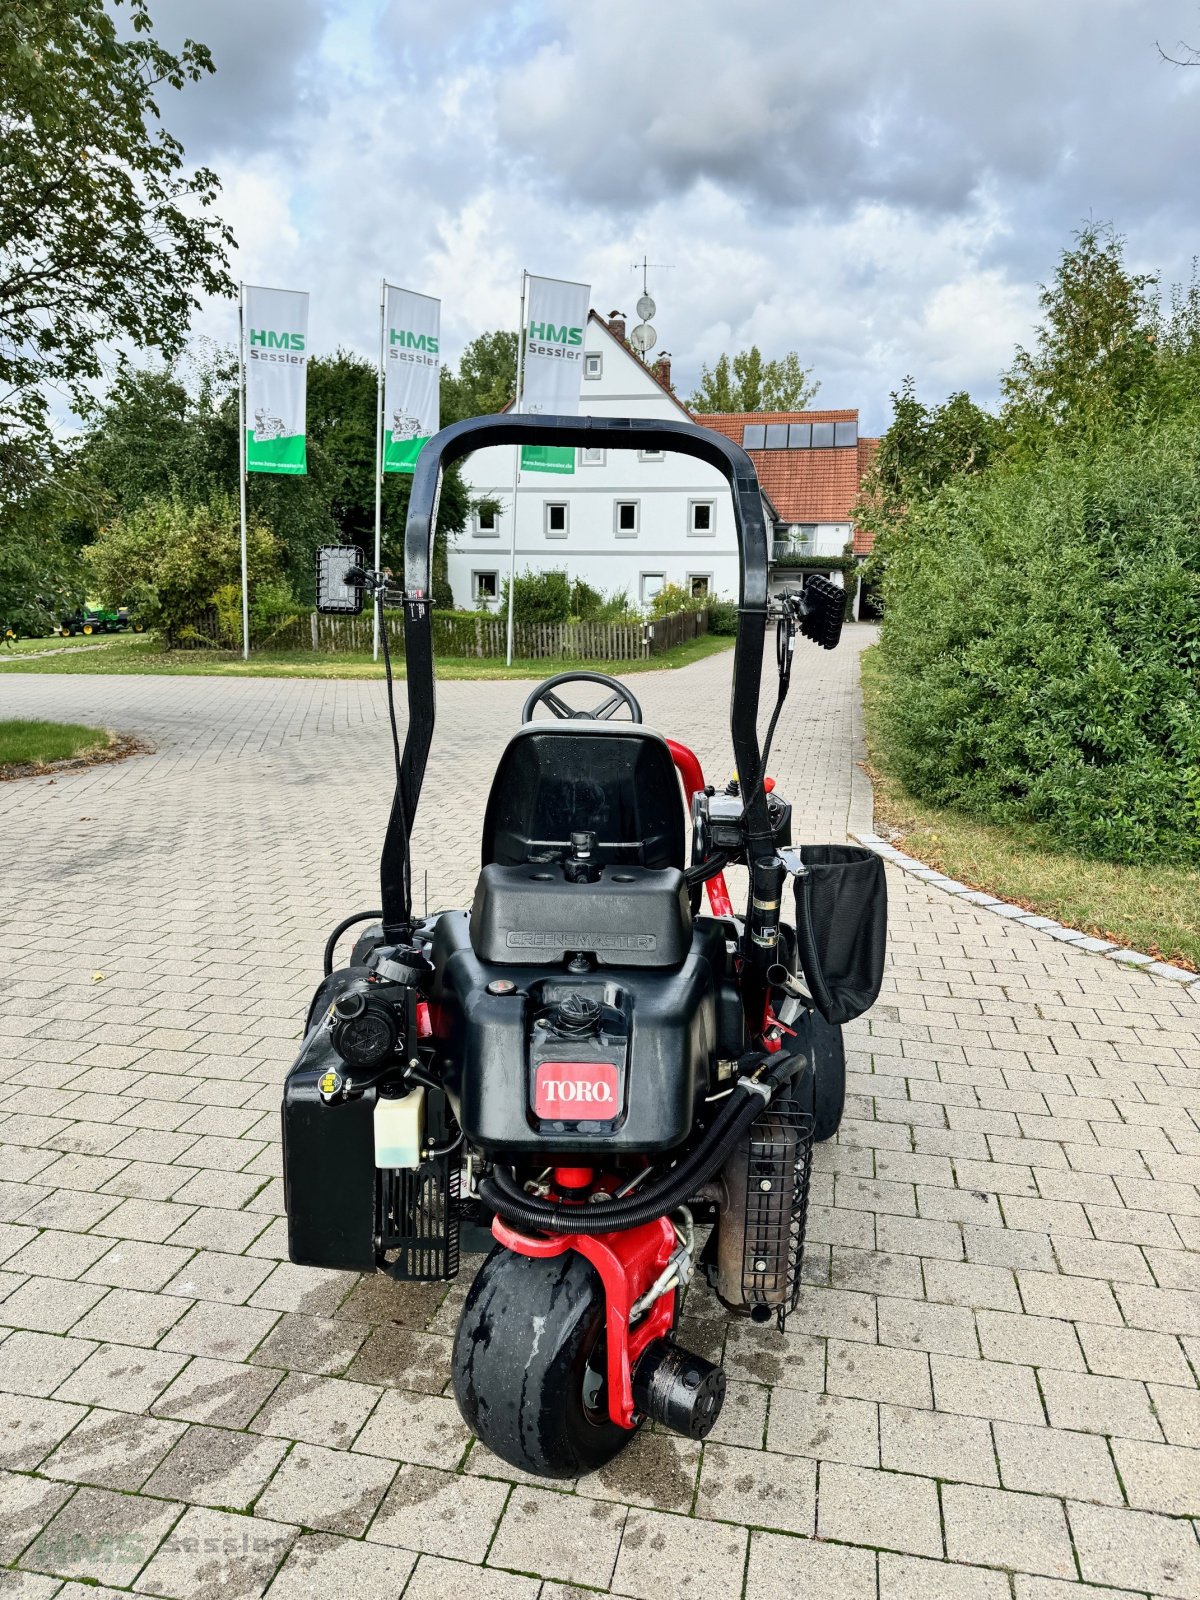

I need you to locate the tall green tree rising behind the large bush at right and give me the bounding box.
[1002,222,1158,451]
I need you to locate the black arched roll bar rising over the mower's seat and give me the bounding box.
[379,414,774,939]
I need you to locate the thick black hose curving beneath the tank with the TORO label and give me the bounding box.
[478,1058,798,1234]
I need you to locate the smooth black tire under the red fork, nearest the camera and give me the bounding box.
[453,1246,635,1478]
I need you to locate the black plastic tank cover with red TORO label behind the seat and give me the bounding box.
[430,910,742,1160]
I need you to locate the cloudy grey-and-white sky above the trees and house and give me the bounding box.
[154,0,1200,430]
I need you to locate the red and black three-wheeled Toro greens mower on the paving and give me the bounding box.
[283,416,886,1478]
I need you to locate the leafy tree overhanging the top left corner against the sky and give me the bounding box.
[0,0,234,498]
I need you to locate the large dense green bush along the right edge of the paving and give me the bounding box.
[883,424,1200,862]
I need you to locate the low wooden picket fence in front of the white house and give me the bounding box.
[259,611,709,661]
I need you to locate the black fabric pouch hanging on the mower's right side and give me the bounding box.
[795,845,888,1022]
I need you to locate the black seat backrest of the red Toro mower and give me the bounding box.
[483,720,685,869]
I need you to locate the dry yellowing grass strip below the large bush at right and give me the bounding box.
[862,650,1200,970]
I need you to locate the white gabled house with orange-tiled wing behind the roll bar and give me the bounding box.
[450,312,859,610]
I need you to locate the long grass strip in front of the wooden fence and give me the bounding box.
[0,634,733,678]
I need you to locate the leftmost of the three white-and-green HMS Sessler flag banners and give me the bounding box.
[243,283,309,475]
